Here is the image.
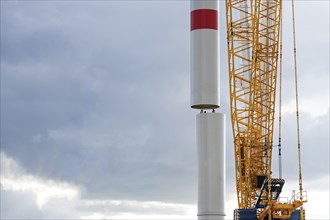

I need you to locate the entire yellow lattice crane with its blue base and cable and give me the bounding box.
[226,0,307,220]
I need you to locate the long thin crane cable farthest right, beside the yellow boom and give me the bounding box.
[292,0,303,201]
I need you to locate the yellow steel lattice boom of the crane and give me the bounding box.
[226,0,281,208]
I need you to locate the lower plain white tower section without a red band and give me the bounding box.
[196,112,226,220]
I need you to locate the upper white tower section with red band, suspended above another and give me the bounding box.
[190,0,220,109]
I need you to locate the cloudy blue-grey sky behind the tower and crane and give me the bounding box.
[0,0,330,219]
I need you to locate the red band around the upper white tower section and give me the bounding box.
[190,9,218,31]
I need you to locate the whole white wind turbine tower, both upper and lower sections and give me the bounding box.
[191,0,226,220]
